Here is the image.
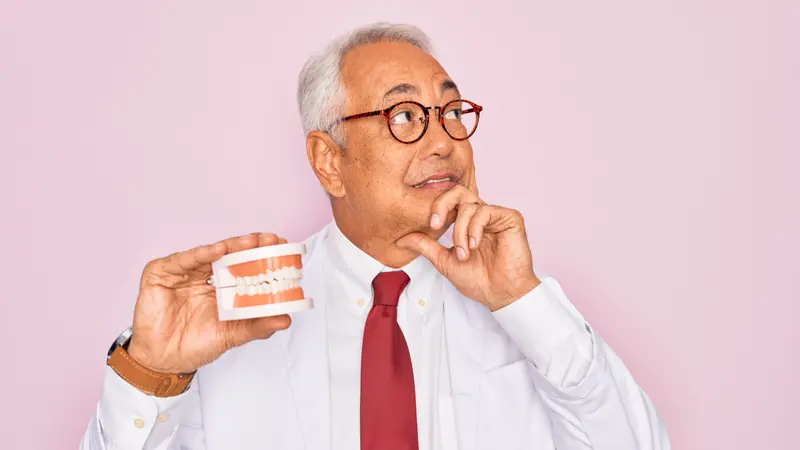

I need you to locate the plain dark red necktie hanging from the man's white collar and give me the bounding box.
[361,271,419,450]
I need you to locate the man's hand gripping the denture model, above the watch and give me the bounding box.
[128,233,291,373]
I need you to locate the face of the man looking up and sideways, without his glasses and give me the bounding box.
[312,43,475,241]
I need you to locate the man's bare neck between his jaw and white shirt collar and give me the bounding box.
[333,204,444,269]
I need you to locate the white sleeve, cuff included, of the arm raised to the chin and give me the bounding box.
[493,277,671,450]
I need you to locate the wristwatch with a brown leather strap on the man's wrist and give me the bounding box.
[106,328,195,397]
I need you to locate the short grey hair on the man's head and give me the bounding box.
[297,22,433,147]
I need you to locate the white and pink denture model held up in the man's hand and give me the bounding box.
[211,244,314,320]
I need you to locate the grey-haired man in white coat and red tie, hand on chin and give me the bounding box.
[82,24,669,450]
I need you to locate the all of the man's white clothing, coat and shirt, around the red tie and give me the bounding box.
[81,222,669,450]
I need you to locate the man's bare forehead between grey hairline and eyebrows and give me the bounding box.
[342,42,449,105]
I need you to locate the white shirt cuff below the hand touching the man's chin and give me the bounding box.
[492,277,594,388]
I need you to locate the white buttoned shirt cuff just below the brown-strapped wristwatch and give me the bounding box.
[97,366,186,449]
